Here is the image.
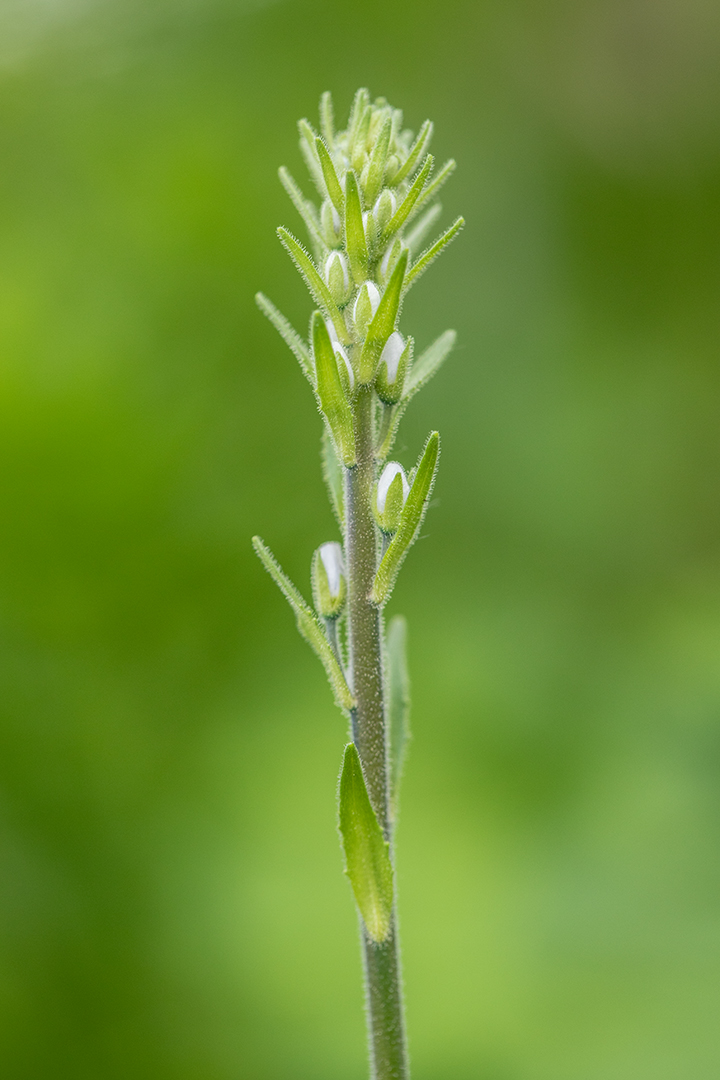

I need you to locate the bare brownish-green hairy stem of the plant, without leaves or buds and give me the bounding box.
[345,387,409,1080]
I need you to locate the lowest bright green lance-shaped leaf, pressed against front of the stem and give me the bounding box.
[339,743,393,942]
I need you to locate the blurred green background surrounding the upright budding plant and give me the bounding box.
[0,0,720,1080]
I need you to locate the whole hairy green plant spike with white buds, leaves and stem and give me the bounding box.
[253,87,464,1080]
